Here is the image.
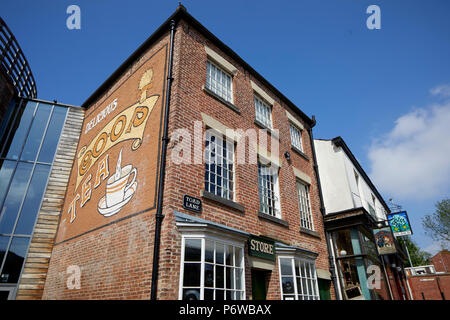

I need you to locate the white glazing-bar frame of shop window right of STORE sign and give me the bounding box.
[278,254,320,300]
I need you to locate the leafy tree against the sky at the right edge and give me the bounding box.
[422,198,450,243]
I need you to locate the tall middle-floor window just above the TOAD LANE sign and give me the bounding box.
[205,130,234,200]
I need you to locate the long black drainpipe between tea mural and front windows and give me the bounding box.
[150,20,175,300]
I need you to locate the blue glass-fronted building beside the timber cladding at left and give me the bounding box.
[0,98,69,300]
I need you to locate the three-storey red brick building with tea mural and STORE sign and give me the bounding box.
[37,6,334,300]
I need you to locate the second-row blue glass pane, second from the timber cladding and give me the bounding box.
[0,163,33,233]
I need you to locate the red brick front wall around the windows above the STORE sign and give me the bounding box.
[158,19,333,299]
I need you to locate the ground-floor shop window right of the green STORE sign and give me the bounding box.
[279,257,319,300]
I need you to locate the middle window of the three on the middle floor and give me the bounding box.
[258,160,281,219]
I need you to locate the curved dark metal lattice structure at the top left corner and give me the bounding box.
[0,17,37,98]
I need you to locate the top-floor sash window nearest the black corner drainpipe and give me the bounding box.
[206,59,233,103]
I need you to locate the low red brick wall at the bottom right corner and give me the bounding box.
[408,273,450,300]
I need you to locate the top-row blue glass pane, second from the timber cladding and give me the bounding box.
[20,103,52,161]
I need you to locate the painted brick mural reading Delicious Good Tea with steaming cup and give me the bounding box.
[56,45,167,242]
